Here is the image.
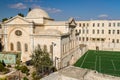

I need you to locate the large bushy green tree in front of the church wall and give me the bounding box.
[31,45,53,78]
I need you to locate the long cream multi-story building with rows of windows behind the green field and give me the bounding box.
[76,20,120,51]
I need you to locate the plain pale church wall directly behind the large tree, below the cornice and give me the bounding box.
[34,36,61,66]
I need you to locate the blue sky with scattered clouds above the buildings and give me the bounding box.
[0,0,120,20]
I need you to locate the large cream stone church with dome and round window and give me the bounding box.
[1,9,80,68]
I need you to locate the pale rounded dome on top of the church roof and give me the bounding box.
[26,8,49,18]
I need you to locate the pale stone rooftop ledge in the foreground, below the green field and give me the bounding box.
[41,66,120,80]
